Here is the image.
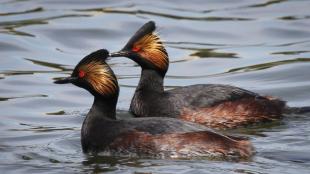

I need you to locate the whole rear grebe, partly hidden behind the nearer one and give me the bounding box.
[111,21,309,129]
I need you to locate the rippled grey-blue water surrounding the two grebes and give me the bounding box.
[0,0,310,174]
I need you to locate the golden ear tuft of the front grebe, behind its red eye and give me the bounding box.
[79,60,118,95]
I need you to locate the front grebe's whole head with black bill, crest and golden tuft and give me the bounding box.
[54,49,119,98]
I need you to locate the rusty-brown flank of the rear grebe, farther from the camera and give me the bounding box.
[179,97,285,129]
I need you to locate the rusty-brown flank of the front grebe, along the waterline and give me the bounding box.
[109,131,253,159]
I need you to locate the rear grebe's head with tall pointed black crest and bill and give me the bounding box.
[111,21,169,76]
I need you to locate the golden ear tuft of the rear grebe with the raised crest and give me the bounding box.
[132,33,169,70]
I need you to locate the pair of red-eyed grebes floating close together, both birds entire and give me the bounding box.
[55,21,306,159]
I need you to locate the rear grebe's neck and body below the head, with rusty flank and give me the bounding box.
[130,70,285,129]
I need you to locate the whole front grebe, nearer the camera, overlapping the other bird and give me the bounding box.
[55,49,253,159]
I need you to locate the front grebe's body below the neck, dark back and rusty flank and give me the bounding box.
[82,115,253,160]
